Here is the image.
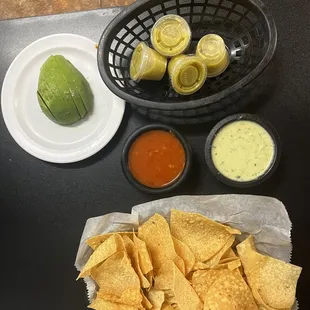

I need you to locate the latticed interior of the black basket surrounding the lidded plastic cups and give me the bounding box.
[108,0,268,103]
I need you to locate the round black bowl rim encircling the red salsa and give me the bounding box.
[121,124,192,194]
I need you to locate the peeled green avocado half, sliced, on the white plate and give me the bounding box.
[37,55,94,125]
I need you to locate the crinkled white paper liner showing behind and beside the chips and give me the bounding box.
[75,195,298,310]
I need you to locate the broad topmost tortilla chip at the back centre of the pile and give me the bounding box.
[170,210,240,262]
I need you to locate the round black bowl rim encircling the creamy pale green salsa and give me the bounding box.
[205,114,281,188]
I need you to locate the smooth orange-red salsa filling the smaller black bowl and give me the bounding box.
[128,130,186,188]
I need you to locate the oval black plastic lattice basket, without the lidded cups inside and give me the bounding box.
[98,0,277,121]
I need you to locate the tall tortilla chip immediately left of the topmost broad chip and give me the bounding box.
[138,213,185,274]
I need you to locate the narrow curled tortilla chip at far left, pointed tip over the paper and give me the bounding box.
[77,234,125,279]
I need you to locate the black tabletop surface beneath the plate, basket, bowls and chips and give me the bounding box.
[0,0,310,310]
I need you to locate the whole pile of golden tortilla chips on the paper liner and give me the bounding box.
[78,210,301,310]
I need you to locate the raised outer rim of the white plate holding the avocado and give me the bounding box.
[1,33,126,164]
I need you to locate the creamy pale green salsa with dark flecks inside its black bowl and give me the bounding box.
[211,120,275,182]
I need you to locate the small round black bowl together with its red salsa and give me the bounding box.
[122,124,191,194]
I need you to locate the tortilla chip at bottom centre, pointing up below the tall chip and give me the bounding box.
[155,260,203,310]
